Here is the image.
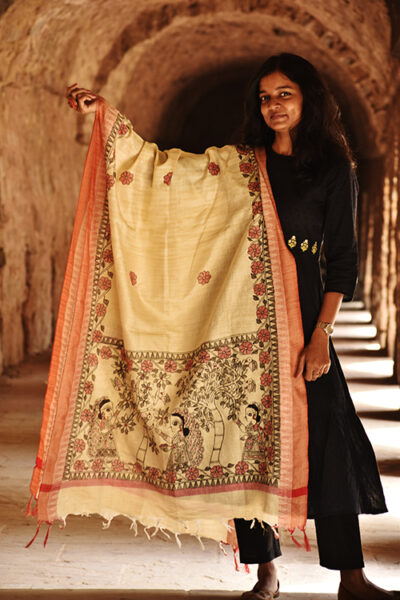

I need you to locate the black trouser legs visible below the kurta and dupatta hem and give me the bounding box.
[235,515,364,570]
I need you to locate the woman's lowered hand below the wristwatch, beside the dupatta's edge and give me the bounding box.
[295,328,331,381]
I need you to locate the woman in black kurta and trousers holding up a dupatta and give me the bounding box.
[60,54,397,600]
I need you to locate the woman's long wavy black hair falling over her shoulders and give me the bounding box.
[243,52,354,181]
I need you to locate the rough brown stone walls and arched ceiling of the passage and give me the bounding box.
[0,0,400,380]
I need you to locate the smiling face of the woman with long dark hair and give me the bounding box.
[259,71,303,133]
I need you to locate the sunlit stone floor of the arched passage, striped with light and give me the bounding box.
[0,304,400,600]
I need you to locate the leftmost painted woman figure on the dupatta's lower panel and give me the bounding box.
[89,396,117,457]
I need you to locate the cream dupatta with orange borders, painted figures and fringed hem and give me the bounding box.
[31,101,308,541]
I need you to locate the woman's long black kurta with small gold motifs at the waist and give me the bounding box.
[267,149,387,518]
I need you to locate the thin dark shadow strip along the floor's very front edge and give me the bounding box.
[0,589,337,600]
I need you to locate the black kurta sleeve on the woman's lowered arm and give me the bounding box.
[324,161,358,301]
